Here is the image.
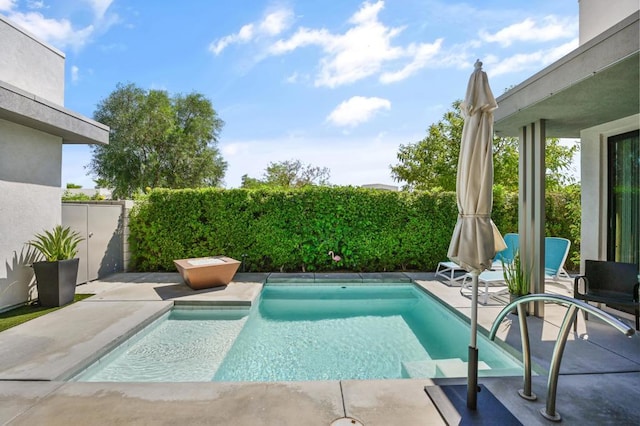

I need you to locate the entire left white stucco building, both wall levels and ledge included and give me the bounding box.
[0,16,109,311]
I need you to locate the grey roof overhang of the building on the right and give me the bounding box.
[494,12,640,138]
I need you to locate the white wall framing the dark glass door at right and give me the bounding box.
[580,114,640,271]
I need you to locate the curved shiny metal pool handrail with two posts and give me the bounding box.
[489,294,635,422]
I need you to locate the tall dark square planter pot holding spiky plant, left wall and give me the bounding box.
[33,258,80,308]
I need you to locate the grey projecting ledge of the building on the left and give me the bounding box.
[0,81,109,144]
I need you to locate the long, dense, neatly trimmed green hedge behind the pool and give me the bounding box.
[129,187,579,271]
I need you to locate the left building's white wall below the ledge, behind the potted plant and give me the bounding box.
[0,120,62,310]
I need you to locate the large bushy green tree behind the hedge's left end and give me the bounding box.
[88,84,227,198]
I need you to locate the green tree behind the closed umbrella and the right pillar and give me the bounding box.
[391,101,579,191]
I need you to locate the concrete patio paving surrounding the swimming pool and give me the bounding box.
[0,273,640,425]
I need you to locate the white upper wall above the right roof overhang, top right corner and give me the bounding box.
[578,0,640,45]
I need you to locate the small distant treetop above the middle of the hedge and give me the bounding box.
[242,160,331,188]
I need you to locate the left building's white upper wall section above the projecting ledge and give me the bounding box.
[0,15,64,105]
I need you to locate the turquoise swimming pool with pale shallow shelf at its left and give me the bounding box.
[73,284,522,382]
